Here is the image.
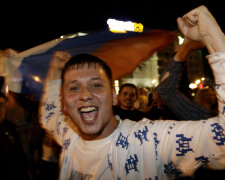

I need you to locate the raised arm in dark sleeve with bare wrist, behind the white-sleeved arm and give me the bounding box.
[157,37,210,120]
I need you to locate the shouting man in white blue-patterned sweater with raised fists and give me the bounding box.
[41,6,225,179]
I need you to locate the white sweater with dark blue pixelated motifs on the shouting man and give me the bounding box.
[40,52,225,180]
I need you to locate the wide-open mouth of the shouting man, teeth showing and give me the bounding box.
[79,106,98,122]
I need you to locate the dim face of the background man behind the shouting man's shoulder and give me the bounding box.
[119,86,137,110]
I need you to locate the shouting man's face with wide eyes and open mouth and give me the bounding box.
[62,64,117,139]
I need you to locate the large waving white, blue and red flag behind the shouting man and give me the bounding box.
[0,30,176,100]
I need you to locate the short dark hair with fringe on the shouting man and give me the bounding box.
[61,54,112,86]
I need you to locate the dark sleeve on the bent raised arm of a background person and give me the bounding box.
[157,60,210,120]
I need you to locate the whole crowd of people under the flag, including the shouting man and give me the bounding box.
[0,6,225,180]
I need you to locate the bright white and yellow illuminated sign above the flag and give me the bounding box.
[107,19,144,33]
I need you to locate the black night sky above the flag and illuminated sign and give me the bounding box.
[0,0,225,51]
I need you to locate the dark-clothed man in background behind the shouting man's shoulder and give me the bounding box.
[113,83,148,121]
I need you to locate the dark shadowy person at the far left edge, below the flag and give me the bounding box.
[0,93,33,180]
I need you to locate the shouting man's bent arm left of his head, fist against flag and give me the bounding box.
[39,51,70,145]
